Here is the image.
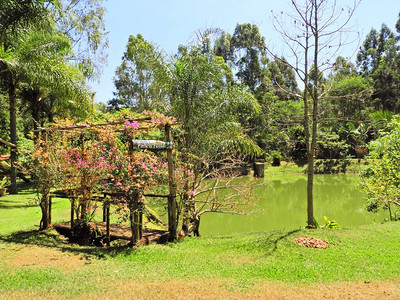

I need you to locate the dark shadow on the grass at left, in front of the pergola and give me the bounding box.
[0,230,132,259]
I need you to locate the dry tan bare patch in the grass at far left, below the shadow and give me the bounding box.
[0,245,86,271]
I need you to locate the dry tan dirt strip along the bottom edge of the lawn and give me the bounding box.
[92,279,400,299]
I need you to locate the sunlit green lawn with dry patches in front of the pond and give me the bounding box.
[0,184,400,299]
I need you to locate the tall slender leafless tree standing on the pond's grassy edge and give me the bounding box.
[272,0,361,228]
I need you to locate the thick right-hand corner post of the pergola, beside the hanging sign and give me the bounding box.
[165,124,178,241]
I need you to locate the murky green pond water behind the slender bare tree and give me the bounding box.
[200,174,387,236]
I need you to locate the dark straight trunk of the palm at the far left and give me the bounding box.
[8,79,17,194]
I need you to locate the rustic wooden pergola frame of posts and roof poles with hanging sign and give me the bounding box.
[37,117,181,246]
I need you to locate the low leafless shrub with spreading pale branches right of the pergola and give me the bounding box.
[176,154,262,236]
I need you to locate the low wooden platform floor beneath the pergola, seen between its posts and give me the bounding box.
[53,222,168,244]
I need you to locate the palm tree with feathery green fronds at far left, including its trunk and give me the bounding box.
[0,26,88,193]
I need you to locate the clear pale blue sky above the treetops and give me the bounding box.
[90,0,400,103]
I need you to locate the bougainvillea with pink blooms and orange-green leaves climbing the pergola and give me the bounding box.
[34,111,175,230]
